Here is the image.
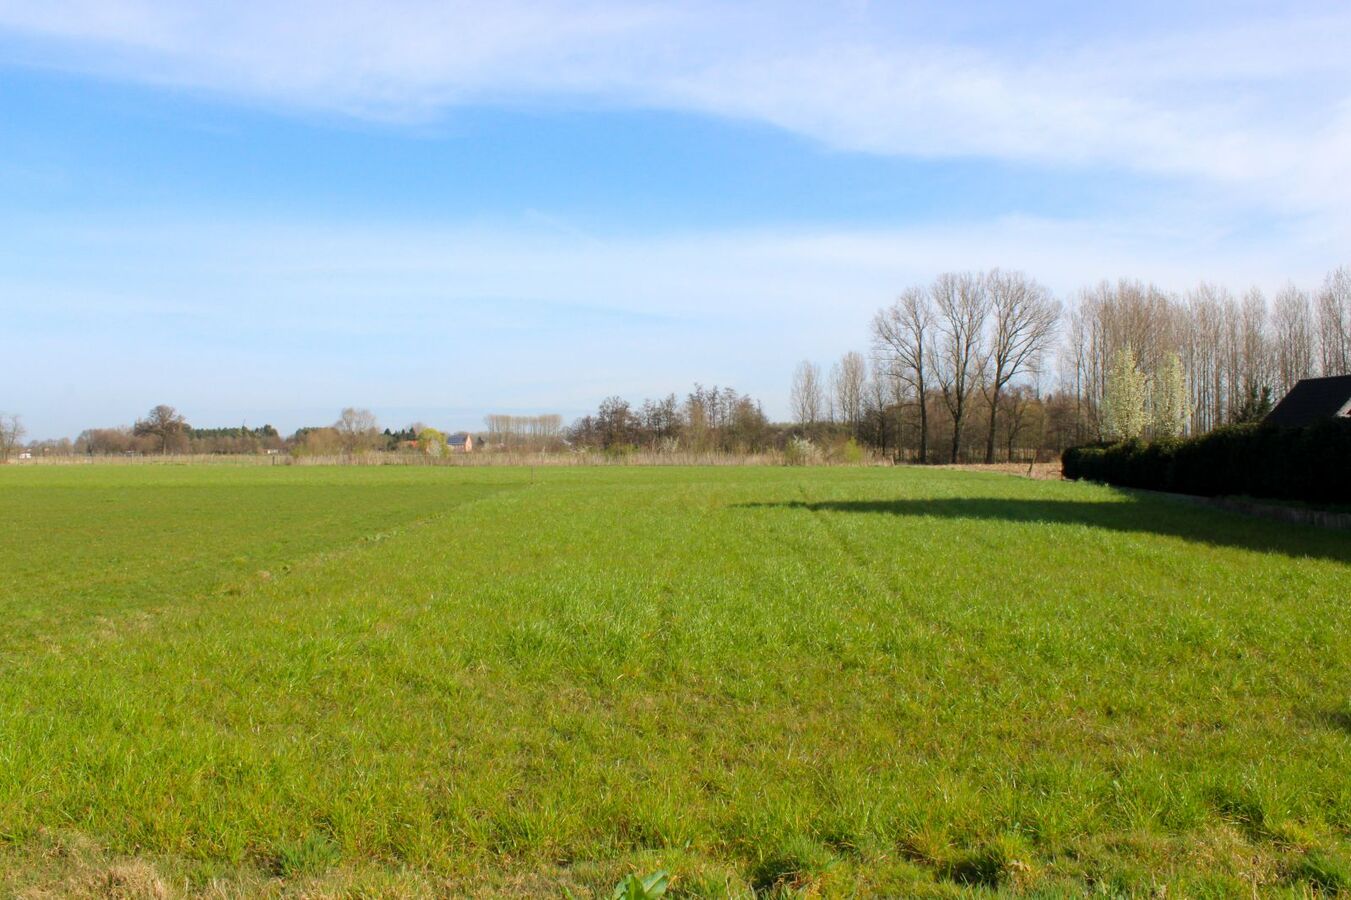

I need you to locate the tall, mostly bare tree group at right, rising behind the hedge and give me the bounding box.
[789,268,1351,462]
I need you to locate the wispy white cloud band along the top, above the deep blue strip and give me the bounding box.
[0,0,1351,209]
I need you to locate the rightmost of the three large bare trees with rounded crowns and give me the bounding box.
[981,269,1061,462]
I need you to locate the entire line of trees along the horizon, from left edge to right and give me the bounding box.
[0,266,1351,462]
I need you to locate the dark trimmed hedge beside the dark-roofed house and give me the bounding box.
[1061,419,1351,504]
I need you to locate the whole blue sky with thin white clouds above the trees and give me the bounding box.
[0,0,1351,438]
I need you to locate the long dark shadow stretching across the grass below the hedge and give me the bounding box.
[738,497,1351,565]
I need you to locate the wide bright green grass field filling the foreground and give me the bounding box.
[0,466,1351,896]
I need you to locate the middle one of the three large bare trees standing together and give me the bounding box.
[929,272,990,462]
